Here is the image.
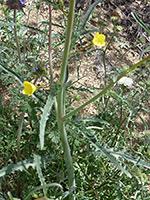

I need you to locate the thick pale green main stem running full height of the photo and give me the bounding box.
[57,0,75,200]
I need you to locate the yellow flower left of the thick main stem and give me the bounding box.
[22,81,37,96]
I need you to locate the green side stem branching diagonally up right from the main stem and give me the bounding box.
[63,55,150,120]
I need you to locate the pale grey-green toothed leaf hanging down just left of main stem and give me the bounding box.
[39,92,54,150]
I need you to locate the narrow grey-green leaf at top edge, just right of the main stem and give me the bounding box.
[80,0,102,30]
